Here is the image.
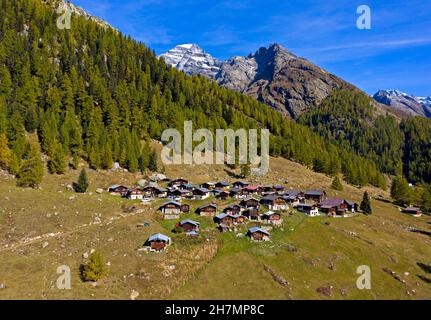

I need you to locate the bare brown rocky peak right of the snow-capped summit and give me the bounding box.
[216,44,354,118]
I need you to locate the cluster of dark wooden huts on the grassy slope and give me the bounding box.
[108,178,358,251]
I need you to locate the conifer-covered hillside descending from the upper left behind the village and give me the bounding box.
[0,0,384,187]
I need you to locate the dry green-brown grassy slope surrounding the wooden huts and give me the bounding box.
[0,146,431,299]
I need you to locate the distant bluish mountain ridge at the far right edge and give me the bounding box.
[374,90,431,118]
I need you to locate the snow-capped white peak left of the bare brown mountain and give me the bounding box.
[160,43,222,79]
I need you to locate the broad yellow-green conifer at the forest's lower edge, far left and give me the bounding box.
[17,145,44,188]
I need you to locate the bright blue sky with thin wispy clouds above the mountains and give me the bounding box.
[72,0,431,96]
